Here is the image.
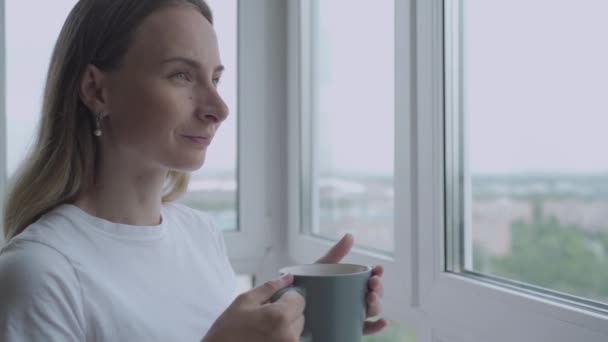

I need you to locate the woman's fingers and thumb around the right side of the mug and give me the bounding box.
[316,234,388,335]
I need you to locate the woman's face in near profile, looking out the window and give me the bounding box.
[104,6,228,171]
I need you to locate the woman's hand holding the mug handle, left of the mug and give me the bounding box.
[203,275,305,342]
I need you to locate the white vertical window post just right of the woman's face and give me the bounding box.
[226,0,286,276]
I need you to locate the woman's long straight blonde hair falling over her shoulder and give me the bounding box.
[3,0,213,241]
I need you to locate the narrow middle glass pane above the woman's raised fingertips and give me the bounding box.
[311,0,395,251]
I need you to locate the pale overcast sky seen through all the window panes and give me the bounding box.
[6,0,608,179]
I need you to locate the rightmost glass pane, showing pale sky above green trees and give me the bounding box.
[461,0,608,302]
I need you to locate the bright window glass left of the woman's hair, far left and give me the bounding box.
[4,0,76,177]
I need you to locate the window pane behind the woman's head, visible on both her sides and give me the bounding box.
[5,0,237,230]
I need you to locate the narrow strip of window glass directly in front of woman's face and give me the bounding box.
[180,0,238,230]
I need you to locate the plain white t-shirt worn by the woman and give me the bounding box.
[0,204,236,342]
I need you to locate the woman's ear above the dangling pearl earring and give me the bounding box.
[80,64,108,113]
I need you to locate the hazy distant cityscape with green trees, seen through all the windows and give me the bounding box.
[181,173,608,303]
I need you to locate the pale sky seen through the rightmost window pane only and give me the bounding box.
[464,0,608,173]
